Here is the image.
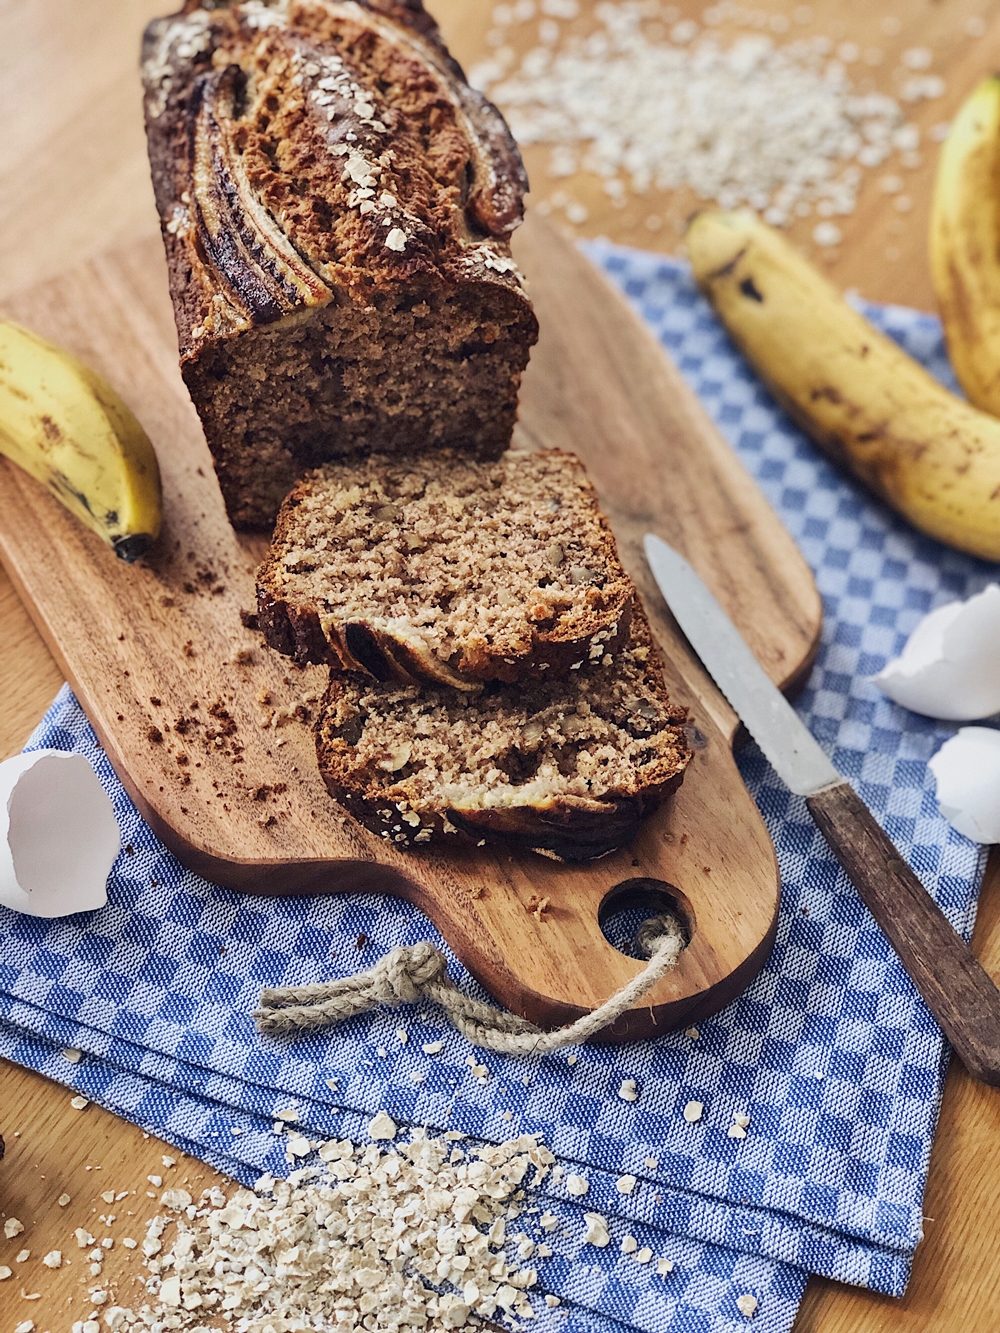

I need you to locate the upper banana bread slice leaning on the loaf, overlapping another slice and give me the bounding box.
[257,449,633,689]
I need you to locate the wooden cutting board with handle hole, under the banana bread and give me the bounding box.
[0,217,820,1040]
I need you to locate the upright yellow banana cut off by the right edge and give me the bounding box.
[931,75,1000,416]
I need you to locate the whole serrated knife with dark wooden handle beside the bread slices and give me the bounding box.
[644,533,1000,1086]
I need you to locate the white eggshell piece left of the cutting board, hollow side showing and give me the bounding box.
[0,750,121,917]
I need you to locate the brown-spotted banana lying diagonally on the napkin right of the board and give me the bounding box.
[687,212,1000,560]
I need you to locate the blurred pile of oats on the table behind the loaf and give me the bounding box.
[471,0,945,231]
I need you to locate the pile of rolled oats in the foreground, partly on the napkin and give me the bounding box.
[73,1117,559,1333]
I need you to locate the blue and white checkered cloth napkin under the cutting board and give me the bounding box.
[0,243,996,1333]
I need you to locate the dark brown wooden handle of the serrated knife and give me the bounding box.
[805,782,1000,1086]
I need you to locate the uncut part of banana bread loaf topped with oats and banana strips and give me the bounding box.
[143,0,537,528]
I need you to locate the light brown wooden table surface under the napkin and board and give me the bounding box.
[0,0,1000,1333]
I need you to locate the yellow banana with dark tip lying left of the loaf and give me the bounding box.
[0,321,161,563]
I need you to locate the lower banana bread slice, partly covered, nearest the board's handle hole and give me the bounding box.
[316,605,691,861]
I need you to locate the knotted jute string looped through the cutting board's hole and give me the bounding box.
[253,916,687,1056]
